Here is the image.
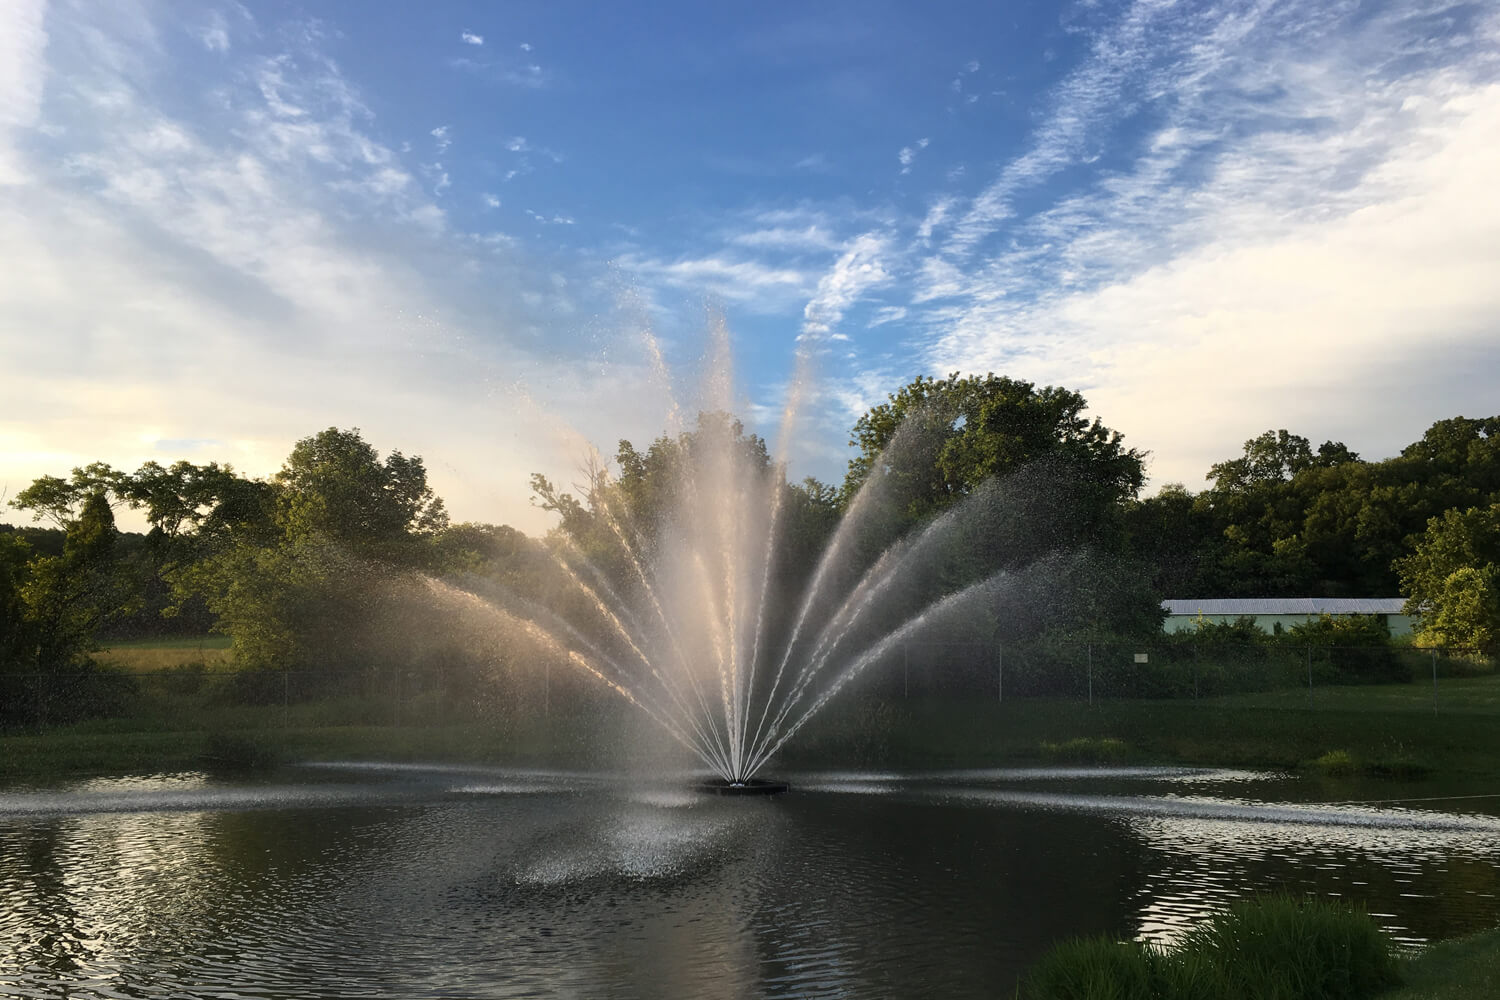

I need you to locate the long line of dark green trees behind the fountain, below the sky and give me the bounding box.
[0,373,1500,704]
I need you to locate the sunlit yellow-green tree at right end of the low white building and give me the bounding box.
[1397,504,1500,652]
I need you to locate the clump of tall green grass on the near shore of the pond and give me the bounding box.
[1022,897,1398,1000]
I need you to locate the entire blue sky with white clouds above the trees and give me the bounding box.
[0,0,1500,531]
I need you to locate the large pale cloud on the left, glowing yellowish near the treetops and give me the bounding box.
[0,4,660,531]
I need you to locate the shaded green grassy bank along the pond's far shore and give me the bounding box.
[0,676,1500,783]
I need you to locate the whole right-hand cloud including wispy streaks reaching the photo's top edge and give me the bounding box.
[914,4,1500,481]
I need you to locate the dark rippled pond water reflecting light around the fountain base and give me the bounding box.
[0,765,1500,997]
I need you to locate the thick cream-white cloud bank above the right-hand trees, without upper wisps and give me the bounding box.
[930,64,1500,487]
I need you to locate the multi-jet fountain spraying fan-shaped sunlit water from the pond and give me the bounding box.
[429,324,1074,795]
